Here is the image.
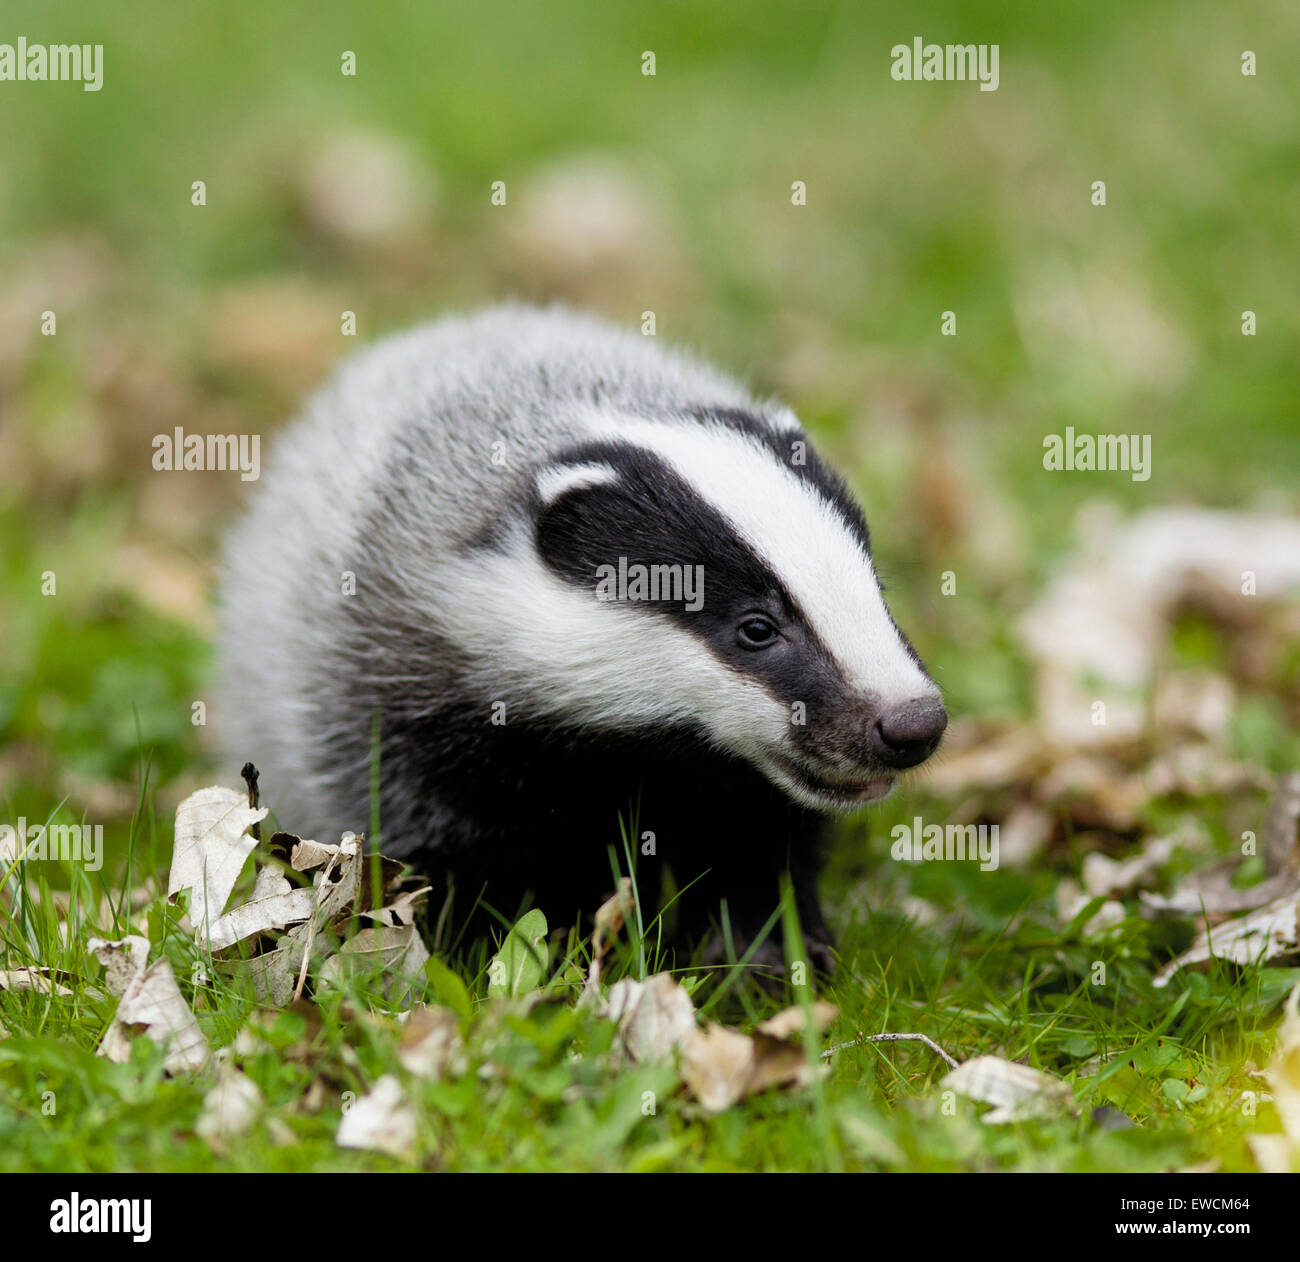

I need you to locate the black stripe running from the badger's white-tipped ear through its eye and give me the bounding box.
[534,442,846,710]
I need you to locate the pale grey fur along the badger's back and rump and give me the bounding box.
[213,307,769,840]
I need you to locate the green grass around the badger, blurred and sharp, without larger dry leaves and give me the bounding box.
[0,0,1300,1170]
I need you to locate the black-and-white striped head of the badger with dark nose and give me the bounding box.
[454,411,948,810]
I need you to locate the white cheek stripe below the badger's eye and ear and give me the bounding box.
[428,537,789,759]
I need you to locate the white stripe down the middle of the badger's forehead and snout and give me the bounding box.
[602,419,937,704]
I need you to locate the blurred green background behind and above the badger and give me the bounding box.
[0,0,1300,845]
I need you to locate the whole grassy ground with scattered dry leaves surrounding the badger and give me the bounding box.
[0,0,1300,1170]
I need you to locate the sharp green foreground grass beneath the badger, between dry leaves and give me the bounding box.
[0,769,1300,1171]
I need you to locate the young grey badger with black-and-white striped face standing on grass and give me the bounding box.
[216,305,948,970]
